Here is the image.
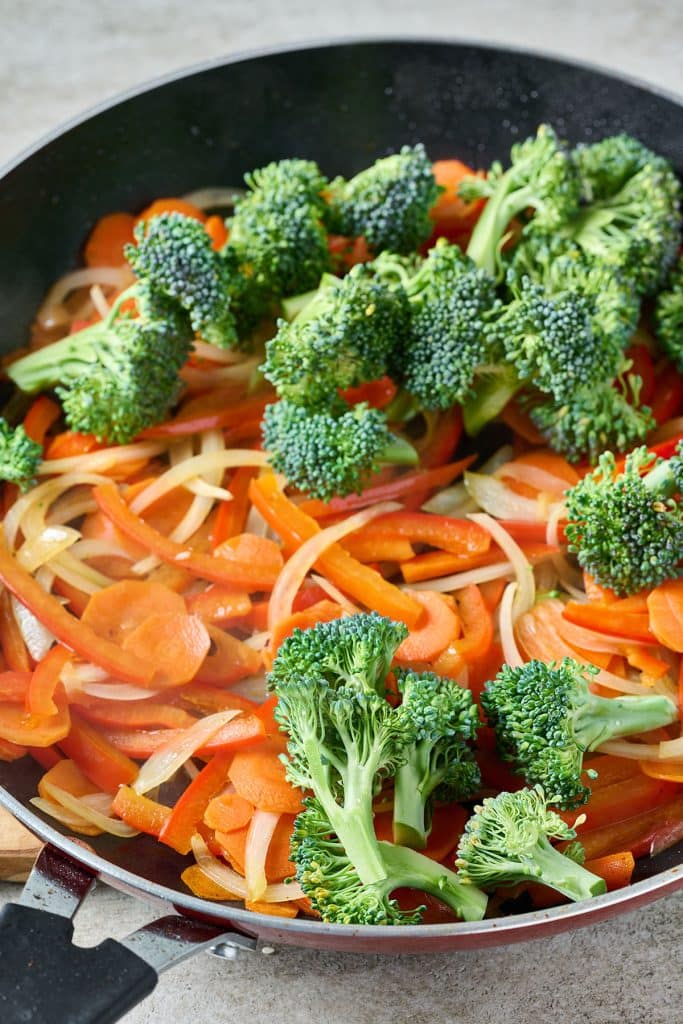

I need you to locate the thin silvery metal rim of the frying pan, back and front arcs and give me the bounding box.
[0,35,683,952]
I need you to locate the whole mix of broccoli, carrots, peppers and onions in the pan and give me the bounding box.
[0,125,683,925]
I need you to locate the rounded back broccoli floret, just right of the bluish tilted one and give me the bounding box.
[228,160,331,306]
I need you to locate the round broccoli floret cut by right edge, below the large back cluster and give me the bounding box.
[566,445,683,594]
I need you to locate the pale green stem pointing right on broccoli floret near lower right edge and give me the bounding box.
[572,693,678,751]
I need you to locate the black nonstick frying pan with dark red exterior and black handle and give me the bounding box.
[0,41,683,1024]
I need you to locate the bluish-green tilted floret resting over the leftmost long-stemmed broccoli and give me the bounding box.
[126,213,238,348]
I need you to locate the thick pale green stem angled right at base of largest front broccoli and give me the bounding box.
[378,842,489,921]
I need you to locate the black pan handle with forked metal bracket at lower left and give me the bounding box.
[0,846,256,1024]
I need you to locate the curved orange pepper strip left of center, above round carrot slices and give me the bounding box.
[91,483,282,591]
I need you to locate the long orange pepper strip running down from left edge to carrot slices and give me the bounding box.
[0,540,154,685]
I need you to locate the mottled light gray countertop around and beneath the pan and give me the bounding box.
[0,0,683,1024]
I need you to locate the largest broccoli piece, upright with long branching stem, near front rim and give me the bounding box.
[269,614,485,924]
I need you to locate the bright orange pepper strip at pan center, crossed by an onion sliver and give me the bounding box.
[249,473,422,629]
